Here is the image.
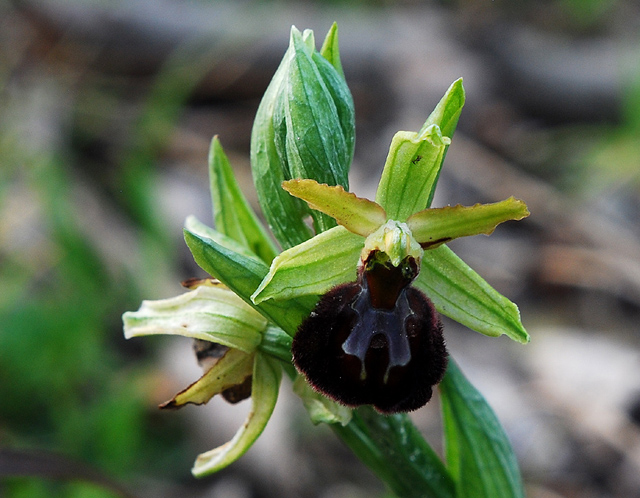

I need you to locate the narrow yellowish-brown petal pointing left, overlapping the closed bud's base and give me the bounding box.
[282,180,387,237]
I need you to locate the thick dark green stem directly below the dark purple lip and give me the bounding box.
[331,407,458,498]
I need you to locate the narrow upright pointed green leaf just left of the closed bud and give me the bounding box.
[209,136,278,264]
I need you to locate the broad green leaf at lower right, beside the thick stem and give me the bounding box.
[439,359,524,498]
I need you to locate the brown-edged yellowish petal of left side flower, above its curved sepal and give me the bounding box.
[160,349,254,408]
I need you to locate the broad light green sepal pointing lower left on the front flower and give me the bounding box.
[251,226,364,304]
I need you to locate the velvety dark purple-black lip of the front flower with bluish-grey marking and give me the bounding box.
[292,253,447,413]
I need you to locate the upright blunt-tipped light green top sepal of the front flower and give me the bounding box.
[376,131,446,221]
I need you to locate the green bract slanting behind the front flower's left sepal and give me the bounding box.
[184,229,316,335]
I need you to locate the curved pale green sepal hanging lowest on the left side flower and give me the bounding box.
[191,354,282,477]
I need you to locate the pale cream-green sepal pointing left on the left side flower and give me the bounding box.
[123,286,267,353]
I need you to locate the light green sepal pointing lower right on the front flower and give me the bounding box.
[414,245,529,343]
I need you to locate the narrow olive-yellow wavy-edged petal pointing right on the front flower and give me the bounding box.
[407,197,529,249]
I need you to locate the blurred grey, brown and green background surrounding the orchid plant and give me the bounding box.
[0,0,640,498]
